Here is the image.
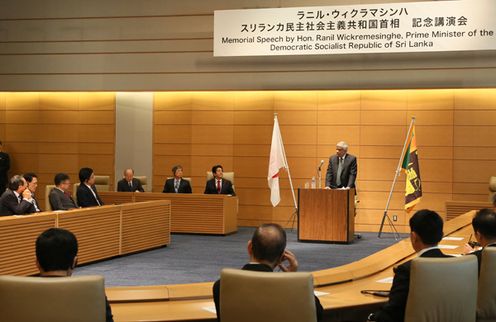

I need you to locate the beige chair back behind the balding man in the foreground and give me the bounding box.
[220,269,317,322]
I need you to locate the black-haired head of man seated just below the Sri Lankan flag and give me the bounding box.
[410,209,443,245]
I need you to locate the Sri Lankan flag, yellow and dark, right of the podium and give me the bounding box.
[402,125,422,212]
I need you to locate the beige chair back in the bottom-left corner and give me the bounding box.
[0,276,105,322]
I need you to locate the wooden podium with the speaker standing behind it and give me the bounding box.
[298,189,355,243]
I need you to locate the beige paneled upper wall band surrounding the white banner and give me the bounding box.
[0,0,496,91]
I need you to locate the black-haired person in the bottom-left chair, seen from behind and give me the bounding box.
[36,228,114,322]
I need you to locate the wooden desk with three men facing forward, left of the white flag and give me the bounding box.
[99,192,238,235]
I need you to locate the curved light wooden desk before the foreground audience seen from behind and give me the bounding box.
[107,212,474,321]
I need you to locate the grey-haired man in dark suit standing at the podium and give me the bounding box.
[326,141,357,189]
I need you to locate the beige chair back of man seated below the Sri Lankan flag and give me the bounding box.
[405,256,478,322]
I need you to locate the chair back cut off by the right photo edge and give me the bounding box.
[477,247,496,322]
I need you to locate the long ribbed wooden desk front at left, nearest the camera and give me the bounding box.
[0,200,171,275]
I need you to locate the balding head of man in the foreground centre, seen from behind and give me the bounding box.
[251,224,286,264]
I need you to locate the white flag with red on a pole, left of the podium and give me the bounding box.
[267,116,288,207]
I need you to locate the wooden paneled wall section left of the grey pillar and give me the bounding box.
[0,92,115,208]
